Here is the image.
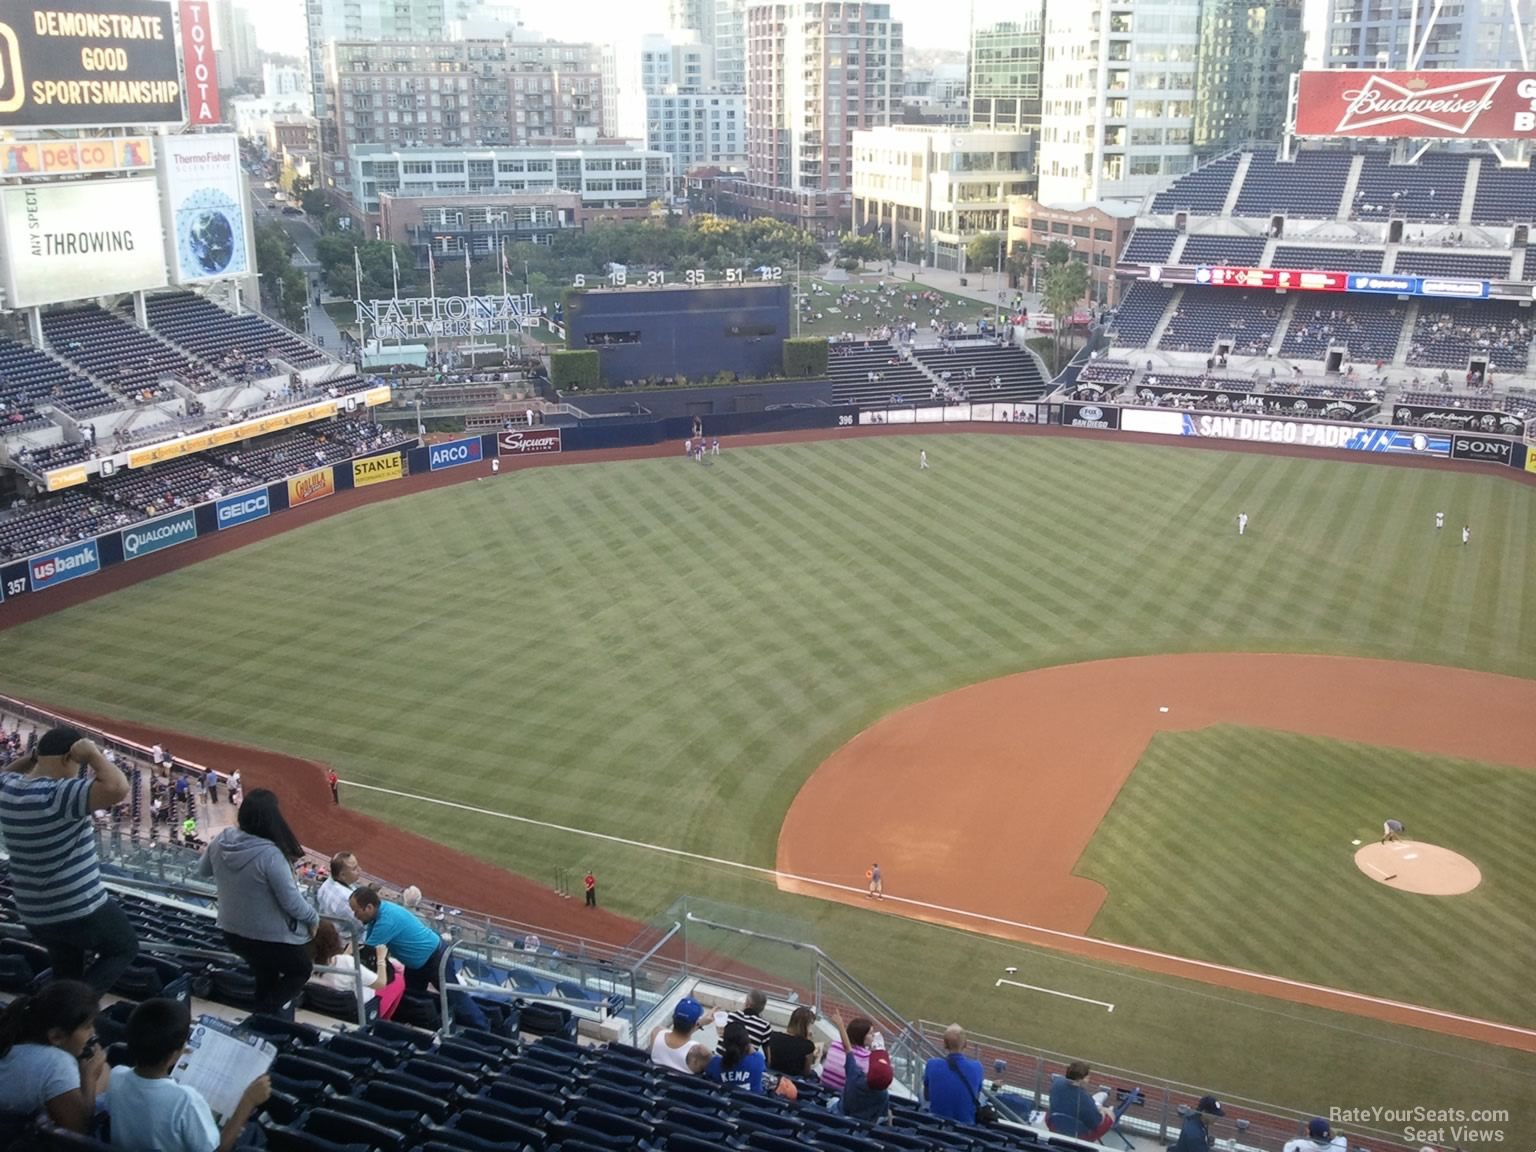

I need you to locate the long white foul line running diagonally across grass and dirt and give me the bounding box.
[339,780,1536,1040]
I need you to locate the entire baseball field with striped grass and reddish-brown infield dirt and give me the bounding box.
[0,435,1536,1143]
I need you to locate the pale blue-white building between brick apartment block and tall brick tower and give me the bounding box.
[617,29,746,174]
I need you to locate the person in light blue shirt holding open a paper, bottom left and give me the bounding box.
[108,998,272,1152]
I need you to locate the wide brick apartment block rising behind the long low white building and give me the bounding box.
[326,40,602,192]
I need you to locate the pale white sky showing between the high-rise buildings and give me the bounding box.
[244,0,966,57]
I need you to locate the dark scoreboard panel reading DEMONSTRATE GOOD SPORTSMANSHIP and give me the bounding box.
[0,0,184,129]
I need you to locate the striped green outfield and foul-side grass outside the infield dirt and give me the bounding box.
[0,435,1536,1130]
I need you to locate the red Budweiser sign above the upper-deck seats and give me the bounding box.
[1296,69,1536,140]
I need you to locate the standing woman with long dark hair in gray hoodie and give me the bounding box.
[197,788,319,1014]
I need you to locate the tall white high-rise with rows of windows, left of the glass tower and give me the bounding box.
[1038,0,1201,204]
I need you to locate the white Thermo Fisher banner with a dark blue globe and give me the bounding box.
[160,135,250,284]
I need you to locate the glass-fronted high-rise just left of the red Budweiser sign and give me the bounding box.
[1195,0,1306,155]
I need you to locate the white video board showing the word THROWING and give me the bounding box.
[0,180,166,309]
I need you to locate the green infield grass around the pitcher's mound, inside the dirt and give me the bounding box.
[1077,717,1536,1026]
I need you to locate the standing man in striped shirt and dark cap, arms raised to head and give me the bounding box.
[0,727,138,994]
